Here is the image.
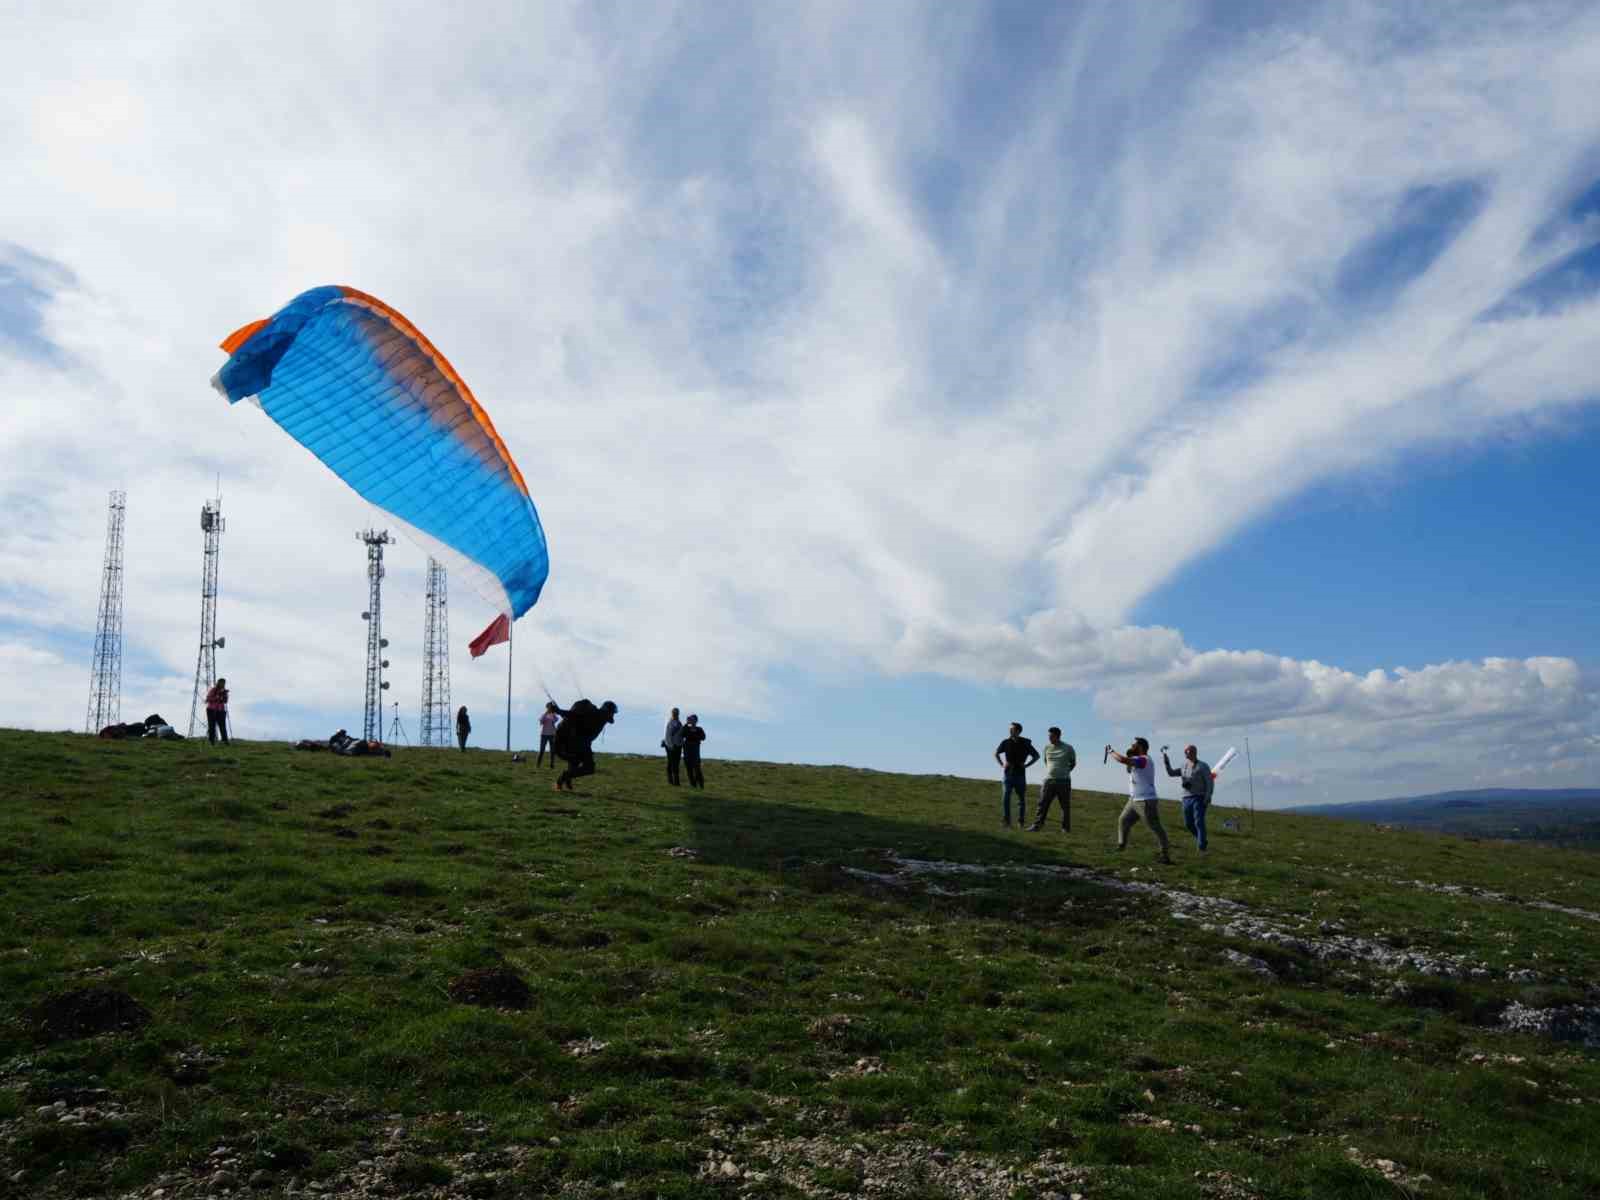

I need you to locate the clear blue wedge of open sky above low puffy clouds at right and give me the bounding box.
[1134,416,1600,670]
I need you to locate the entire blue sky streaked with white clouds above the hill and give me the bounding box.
[0,2,1600,803]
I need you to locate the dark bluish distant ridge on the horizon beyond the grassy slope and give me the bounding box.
[1283,787,1600,846]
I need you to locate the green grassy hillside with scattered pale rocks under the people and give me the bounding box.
[0,731,1600,1200]
